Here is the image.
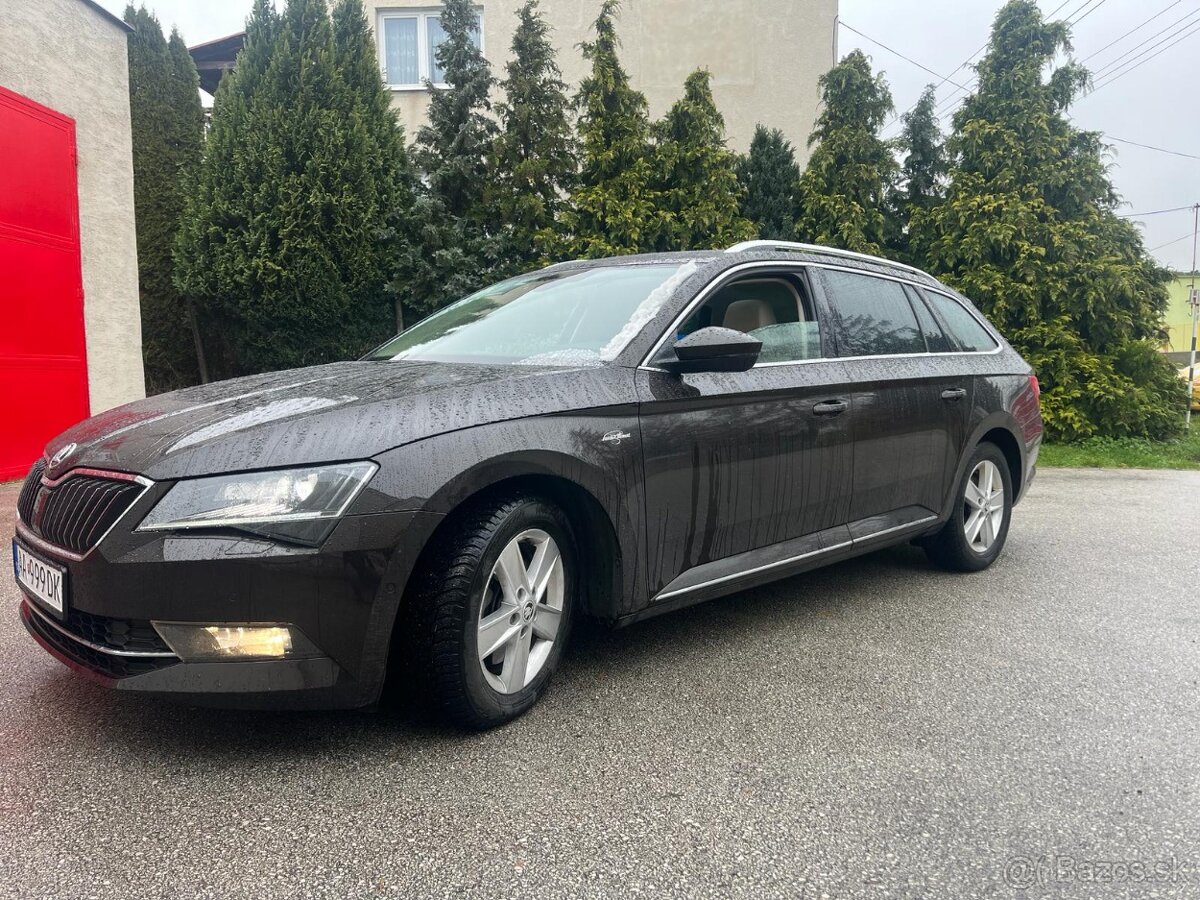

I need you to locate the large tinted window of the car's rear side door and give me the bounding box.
[822,269,925,356]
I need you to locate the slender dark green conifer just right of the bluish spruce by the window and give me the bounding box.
[496,0,578,269]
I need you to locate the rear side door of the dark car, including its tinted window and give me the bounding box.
[820,268,972,539]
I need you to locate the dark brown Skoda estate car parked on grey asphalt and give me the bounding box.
[13,241,1042,727]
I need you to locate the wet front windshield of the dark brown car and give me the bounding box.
[367,263,696,366]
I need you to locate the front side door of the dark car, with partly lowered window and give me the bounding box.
[637,264,854,600]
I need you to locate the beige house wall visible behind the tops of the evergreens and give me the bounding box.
[367,0,838,164]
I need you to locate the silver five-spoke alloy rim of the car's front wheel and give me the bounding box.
[478,528,566,694]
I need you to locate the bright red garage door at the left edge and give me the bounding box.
[0,88,88,481]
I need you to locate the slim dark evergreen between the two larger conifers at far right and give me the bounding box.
[894,85,947,265]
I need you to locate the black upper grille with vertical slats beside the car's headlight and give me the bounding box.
[17,463,143,553]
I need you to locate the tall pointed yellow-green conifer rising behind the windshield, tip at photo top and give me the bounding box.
[560,0,662,258]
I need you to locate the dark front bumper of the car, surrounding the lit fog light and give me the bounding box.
[17,498,440,709]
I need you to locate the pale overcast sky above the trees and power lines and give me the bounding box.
[100,0,1200,270]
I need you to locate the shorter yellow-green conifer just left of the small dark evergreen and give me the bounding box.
[654,70,755,250]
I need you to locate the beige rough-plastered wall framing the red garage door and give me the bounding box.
[0,0,145,413]
